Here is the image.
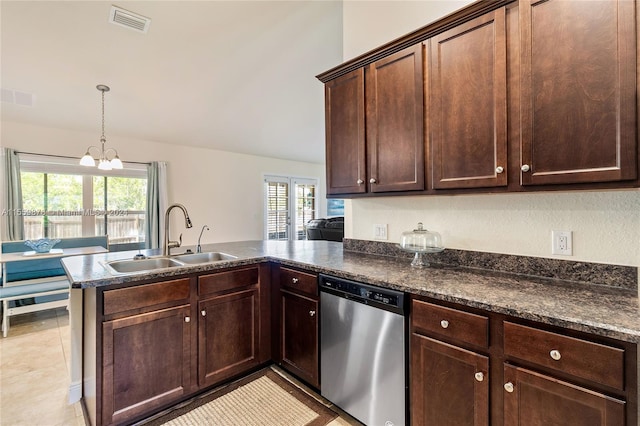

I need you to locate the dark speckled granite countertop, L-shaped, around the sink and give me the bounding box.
[62,241,640,343]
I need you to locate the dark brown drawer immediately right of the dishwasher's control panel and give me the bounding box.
[411,300,489,348]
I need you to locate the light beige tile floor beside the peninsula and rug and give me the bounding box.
[0,308,361,426]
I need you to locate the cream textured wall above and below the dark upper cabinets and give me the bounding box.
[343,1,640,266]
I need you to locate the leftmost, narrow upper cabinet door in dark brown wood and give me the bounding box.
[325,69,367,195]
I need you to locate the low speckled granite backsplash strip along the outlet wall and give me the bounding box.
[343,238,638,290]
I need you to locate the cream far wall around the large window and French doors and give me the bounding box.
[0,122,326,245]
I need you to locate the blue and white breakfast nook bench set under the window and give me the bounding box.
[0,236,109,337]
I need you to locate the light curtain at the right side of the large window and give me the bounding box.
[146,161,168,248]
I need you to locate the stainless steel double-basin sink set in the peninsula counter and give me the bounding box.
[103,252,237,275]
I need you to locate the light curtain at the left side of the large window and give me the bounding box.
[2,148,24,241]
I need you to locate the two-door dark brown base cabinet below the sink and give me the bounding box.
[94,263,271,425]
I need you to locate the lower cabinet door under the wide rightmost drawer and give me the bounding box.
[504,364,625,426]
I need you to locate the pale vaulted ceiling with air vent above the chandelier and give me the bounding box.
[0,0,342,163]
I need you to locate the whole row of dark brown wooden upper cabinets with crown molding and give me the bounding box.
[318,0,640,197]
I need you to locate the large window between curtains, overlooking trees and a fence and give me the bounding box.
[20,154,147,250]
